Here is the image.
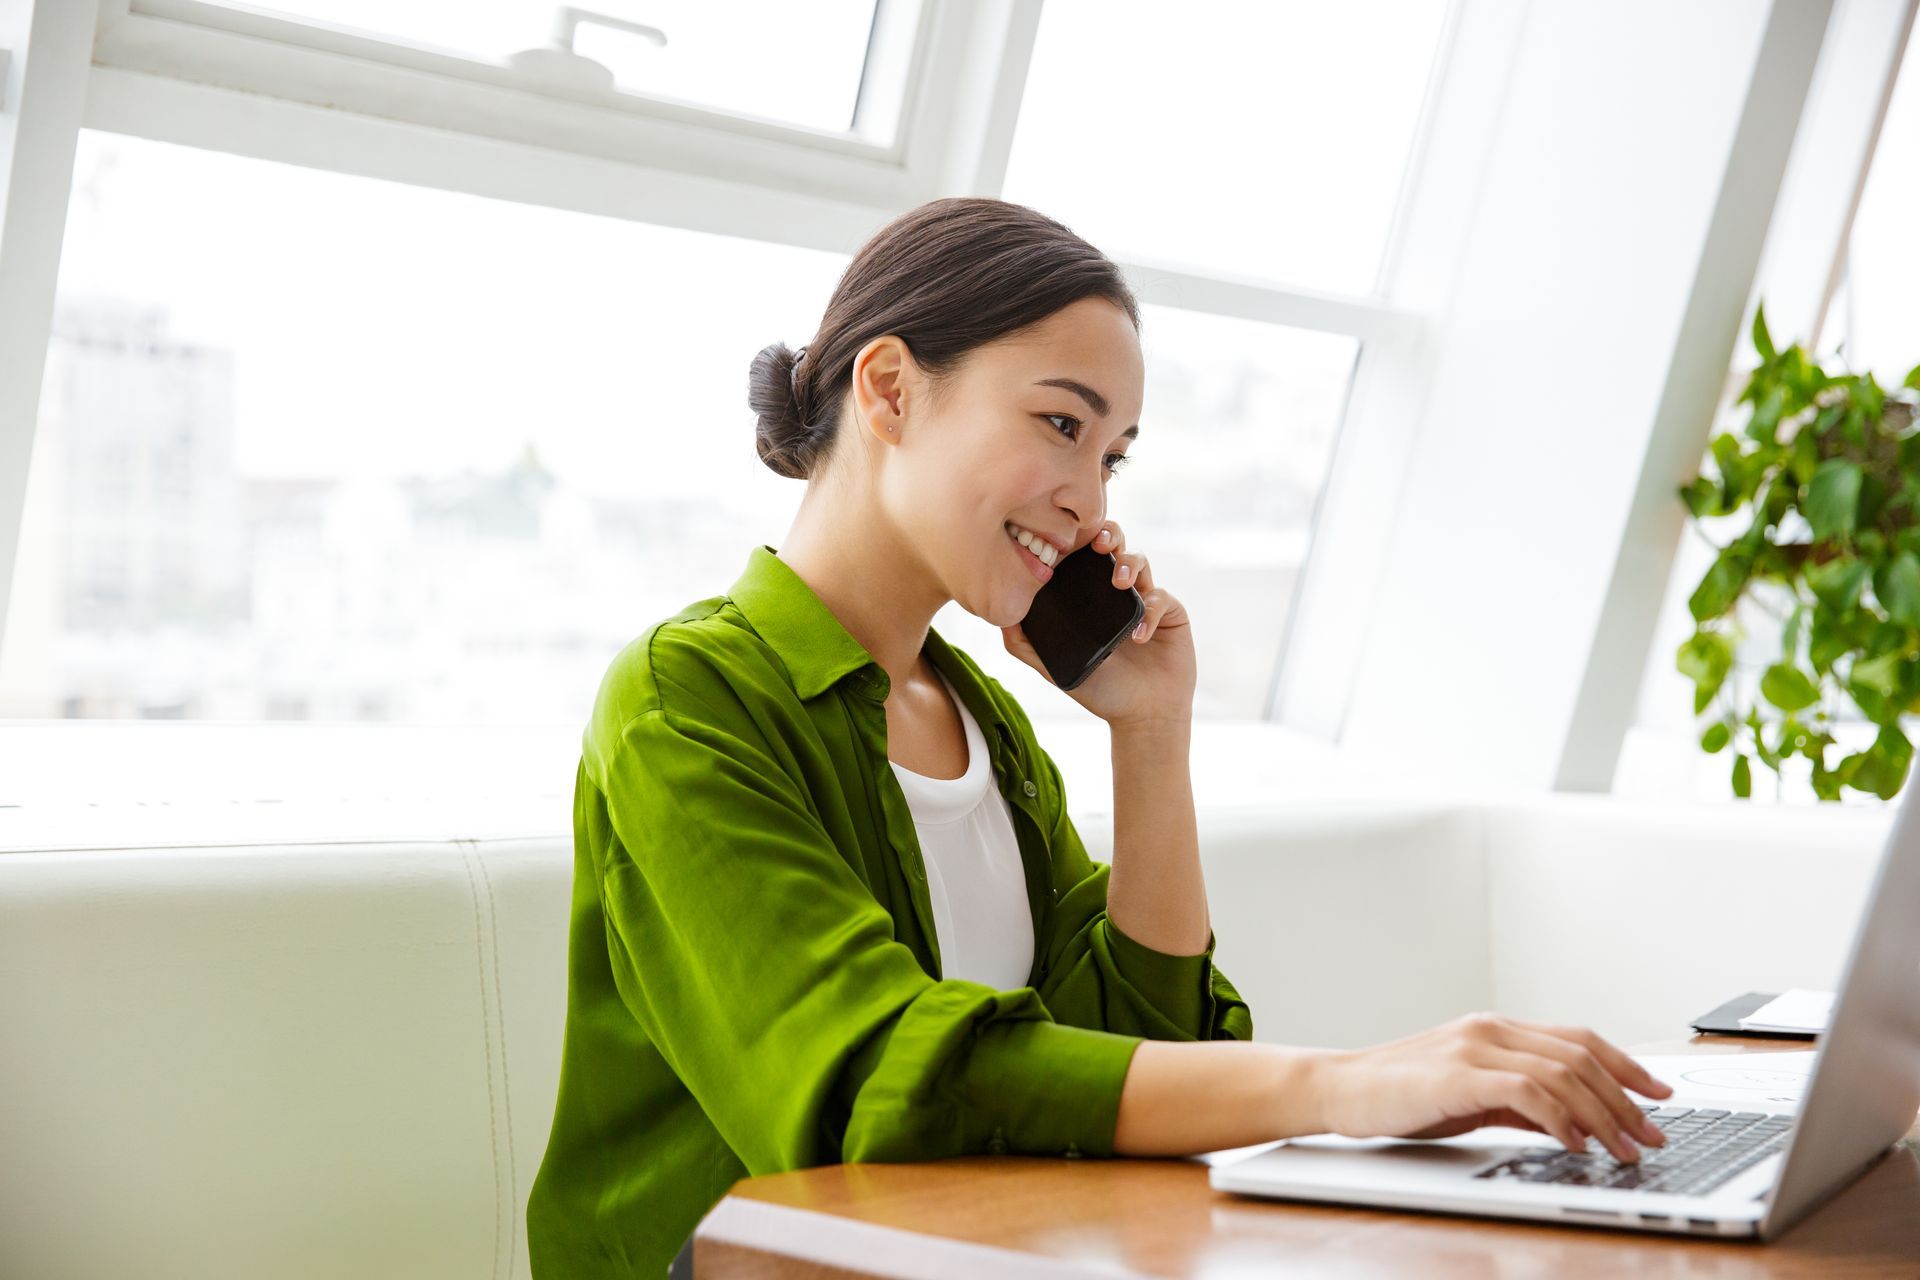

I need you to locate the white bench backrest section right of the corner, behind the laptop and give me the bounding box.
[1486,796,1895,1044]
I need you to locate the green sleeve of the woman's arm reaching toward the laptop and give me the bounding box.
[588,704,1144,1174]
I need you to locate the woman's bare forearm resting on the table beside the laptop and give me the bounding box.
[1114,1040,1332,1155]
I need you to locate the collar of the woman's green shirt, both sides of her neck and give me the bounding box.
[728,543,1014,743]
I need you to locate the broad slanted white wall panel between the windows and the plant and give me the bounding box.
[1342,0,1826,789]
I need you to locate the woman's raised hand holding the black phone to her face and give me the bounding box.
[1000,520,1194,727]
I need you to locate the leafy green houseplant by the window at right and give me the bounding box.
[1674,307,1920,800]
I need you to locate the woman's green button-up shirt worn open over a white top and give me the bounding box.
[526,545,1252,1280]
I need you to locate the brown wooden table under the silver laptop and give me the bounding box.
[693,1036,1920,1280]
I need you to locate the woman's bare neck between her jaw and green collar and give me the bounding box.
[780,486,950,702]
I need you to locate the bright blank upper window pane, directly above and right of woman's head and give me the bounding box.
[1004,0,1446,294]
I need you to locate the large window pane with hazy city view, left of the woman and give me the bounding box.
[0,132,845,725]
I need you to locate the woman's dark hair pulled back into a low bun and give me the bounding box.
[747,196,1140,480]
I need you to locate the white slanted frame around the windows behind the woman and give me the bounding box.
[0,0,1519,756]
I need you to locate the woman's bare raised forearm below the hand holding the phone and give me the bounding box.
[1106,720,1212,956]
